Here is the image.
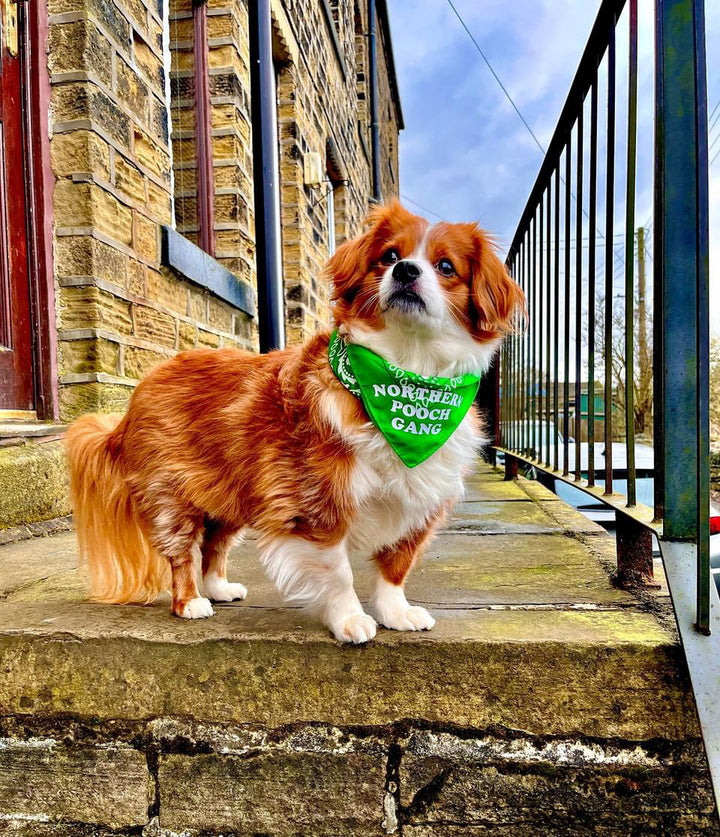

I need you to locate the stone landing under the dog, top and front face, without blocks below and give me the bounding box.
[0,468,697,740]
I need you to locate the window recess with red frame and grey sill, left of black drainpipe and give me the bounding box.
[160,0,256,320]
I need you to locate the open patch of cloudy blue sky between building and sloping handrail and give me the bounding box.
[391,0,593,232]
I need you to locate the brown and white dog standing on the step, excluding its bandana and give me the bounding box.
[67,202,524,643]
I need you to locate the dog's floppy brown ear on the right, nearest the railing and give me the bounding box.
[470,227,527,340]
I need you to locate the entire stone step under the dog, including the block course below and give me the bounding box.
[0,467,720,837]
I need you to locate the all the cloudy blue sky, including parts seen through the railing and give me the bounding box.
[388,0,720,333]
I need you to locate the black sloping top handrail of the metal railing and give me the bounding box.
[508,0,626,259]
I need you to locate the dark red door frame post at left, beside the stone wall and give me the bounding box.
[18,0,58,421]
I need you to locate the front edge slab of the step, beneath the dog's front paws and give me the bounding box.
[0,602,697,739]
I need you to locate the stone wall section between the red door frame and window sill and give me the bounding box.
[48,0,253,420]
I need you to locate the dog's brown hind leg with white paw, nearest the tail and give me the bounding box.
[150,501,215,619]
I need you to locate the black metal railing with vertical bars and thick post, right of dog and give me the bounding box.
[495,0,720,808]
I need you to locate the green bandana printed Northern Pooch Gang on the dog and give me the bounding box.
[328,330,480,468]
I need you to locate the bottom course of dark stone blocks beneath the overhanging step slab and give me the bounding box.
[0,716,720,837]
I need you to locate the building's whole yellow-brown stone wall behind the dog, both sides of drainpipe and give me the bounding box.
[48,0,397,420]
